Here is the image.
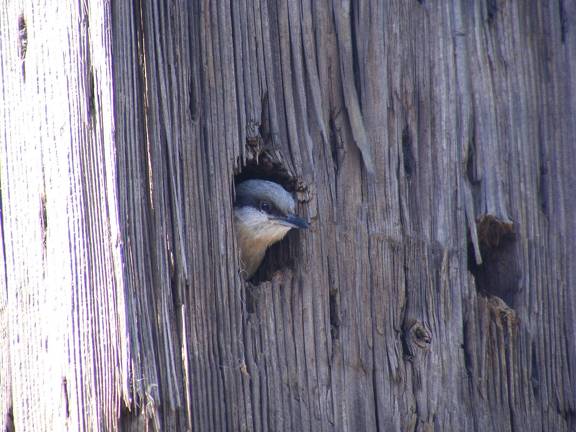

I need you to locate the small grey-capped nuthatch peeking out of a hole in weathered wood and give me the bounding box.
[234,179,308,279]
